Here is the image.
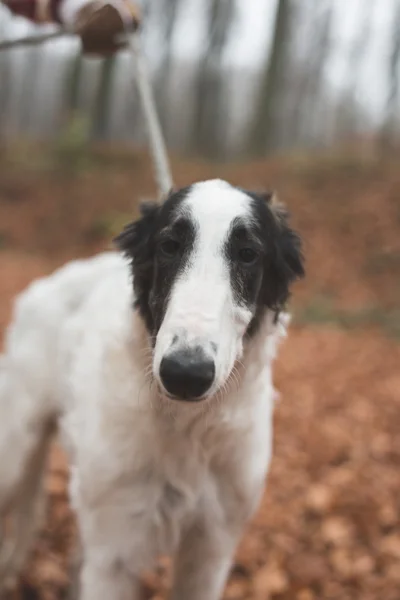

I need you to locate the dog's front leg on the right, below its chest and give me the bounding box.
[171,521,238,600]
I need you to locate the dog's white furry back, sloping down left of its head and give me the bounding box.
[0,252,122,400]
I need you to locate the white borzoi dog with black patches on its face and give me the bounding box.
[0,180,304,600]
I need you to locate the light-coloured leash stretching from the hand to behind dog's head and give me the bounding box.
[0,30,173,200]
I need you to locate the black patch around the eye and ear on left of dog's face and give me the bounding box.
[115,186,196,336]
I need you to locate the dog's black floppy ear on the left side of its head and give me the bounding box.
[114,203,160,328]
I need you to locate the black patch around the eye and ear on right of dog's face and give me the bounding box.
[225,191,304,335]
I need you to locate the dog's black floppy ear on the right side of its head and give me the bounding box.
[263,195,305,312]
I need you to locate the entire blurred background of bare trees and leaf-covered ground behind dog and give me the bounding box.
[0,0,400,600]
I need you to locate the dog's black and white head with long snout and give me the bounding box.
[116,180,304,400]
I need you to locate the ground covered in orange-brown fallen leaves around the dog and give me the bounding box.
[0,145,400,600]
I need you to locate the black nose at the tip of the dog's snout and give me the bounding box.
[160,348,215,400]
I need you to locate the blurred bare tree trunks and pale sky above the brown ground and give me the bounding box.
[0,0,400,159]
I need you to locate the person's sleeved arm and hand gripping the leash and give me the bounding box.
[0,0,140,56]
